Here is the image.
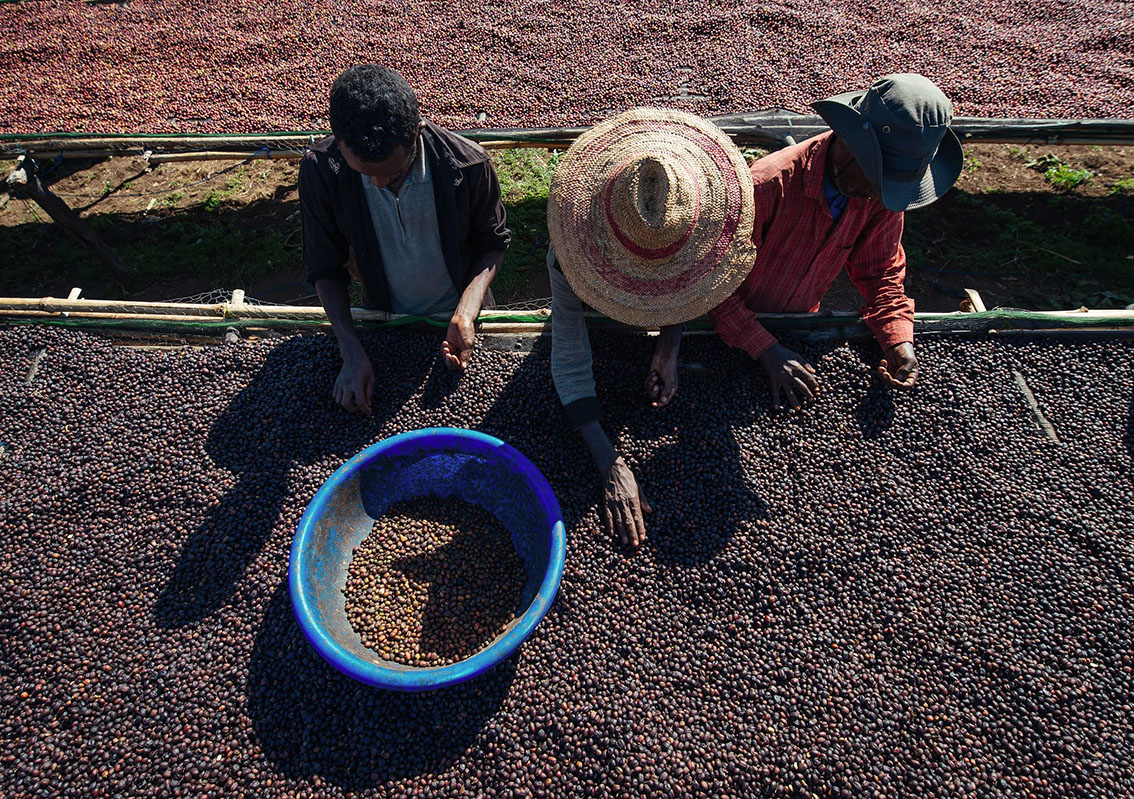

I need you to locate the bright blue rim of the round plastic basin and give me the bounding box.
[288,427,567,691]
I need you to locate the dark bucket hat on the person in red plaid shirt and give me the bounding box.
[811,74,965,211]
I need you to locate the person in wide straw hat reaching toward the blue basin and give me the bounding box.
[548,109,756,547]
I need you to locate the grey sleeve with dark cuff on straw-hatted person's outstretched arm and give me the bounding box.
[548,247,602,430]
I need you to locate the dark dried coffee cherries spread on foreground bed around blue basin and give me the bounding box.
[0,326,1134,799]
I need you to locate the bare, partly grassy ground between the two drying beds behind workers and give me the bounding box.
[0,145,1134,311]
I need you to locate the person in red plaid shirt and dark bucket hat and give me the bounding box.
[710,74,964,408]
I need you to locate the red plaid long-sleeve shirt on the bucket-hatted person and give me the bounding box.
[709,133,914,358]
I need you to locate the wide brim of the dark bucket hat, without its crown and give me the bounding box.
[811,92,965,211]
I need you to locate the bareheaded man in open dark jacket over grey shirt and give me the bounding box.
[299,63,510,414]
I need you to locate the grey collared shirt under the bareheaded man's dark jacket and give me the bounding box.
[358,135,460,315]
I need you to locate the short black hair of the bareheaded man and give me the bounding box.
[330,63,421,161]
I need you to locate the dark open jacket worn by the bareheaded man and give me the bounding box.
[299,122,511,311]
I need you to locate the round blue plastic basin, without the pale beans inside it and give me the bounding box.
[288,427,566,691]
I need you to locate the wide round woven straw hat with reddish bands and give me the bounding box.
[548,109,756,328]
